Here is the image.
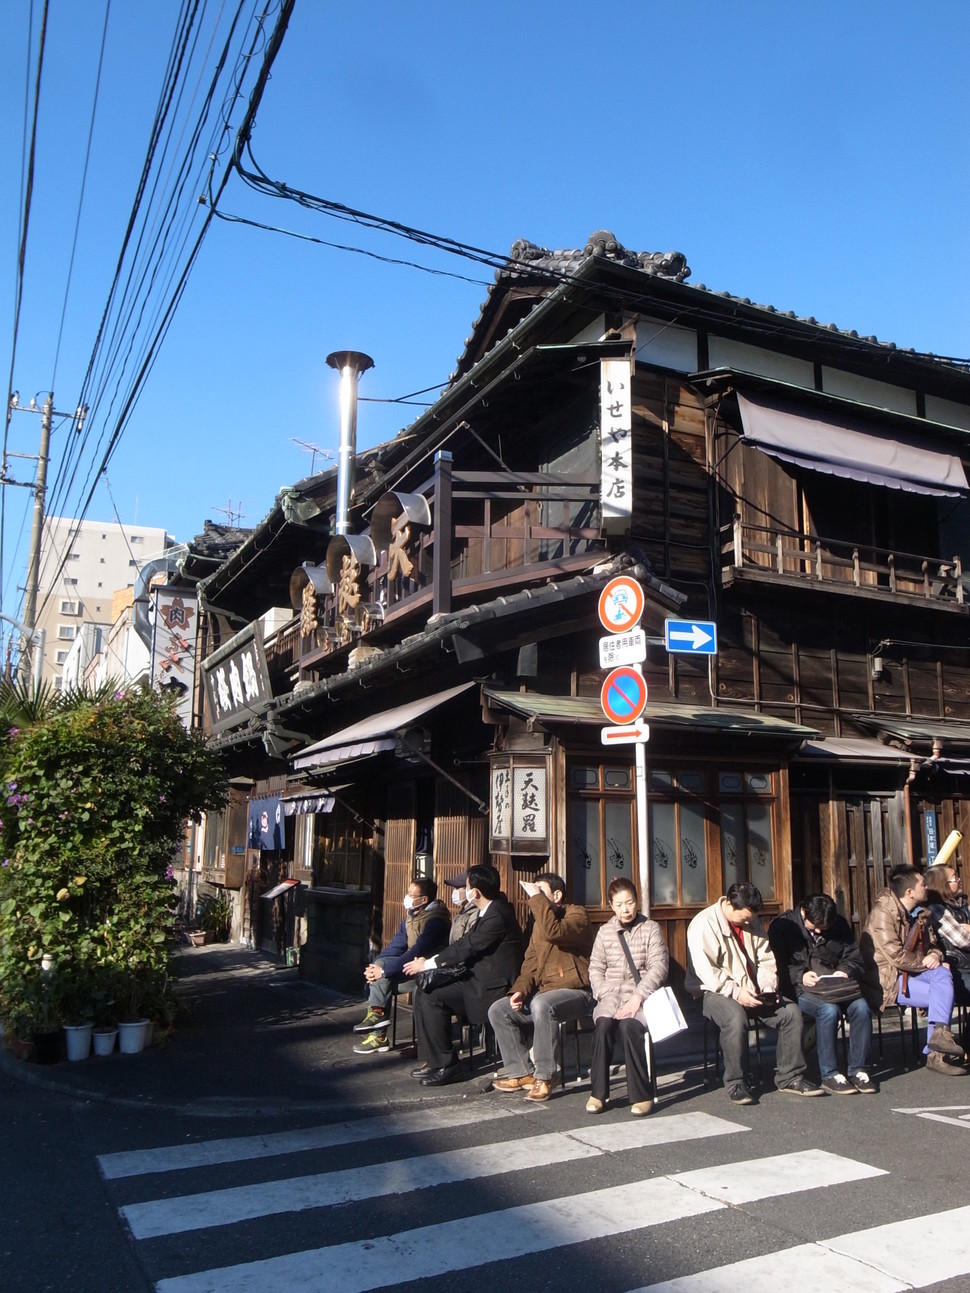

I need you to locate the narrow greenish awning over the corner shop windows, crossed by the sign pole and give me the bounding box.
[485,687,819,738]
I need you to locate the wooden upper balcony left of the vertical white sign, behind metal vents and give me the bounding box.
[300,455,605,670]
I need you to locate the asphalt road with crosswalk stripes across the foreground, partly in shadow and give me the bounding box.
[0,941,970,1293]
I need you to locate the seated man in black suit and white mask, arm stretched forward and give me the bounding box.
[404,866,523,1086]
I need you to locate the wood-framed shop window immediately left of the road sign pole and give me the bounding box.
[566,763,638,906]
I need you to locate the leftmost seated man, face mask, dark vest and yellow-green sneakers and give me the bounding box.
[353,875,451,1055]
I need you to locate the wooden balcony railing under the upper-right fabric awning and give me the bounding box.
[720,516,964,605]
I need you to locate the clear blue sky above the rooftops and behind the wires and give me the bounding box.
[0,0,970,625]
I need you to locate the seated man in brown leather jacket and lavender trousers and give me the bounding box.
[859,866,967,1077]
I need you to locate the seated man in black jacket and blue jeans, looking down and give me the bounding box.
[768,893,876,1095]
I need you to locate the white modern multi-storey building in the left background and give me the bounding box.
[36,516,173,688]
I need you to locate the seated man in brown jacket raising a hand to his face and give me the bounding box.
[489,871,592,1100]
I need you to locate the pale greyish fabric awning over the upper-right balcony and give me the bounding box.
[737,390,967,498]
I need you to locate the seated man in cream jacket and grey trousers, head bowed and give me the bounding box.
[685,883,824,1104]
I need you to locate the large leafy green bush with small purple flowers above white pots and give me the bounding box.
[0,684,226,1036]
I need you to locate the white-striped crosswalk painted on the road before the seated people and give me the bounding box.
[98,1102,970,1293]
